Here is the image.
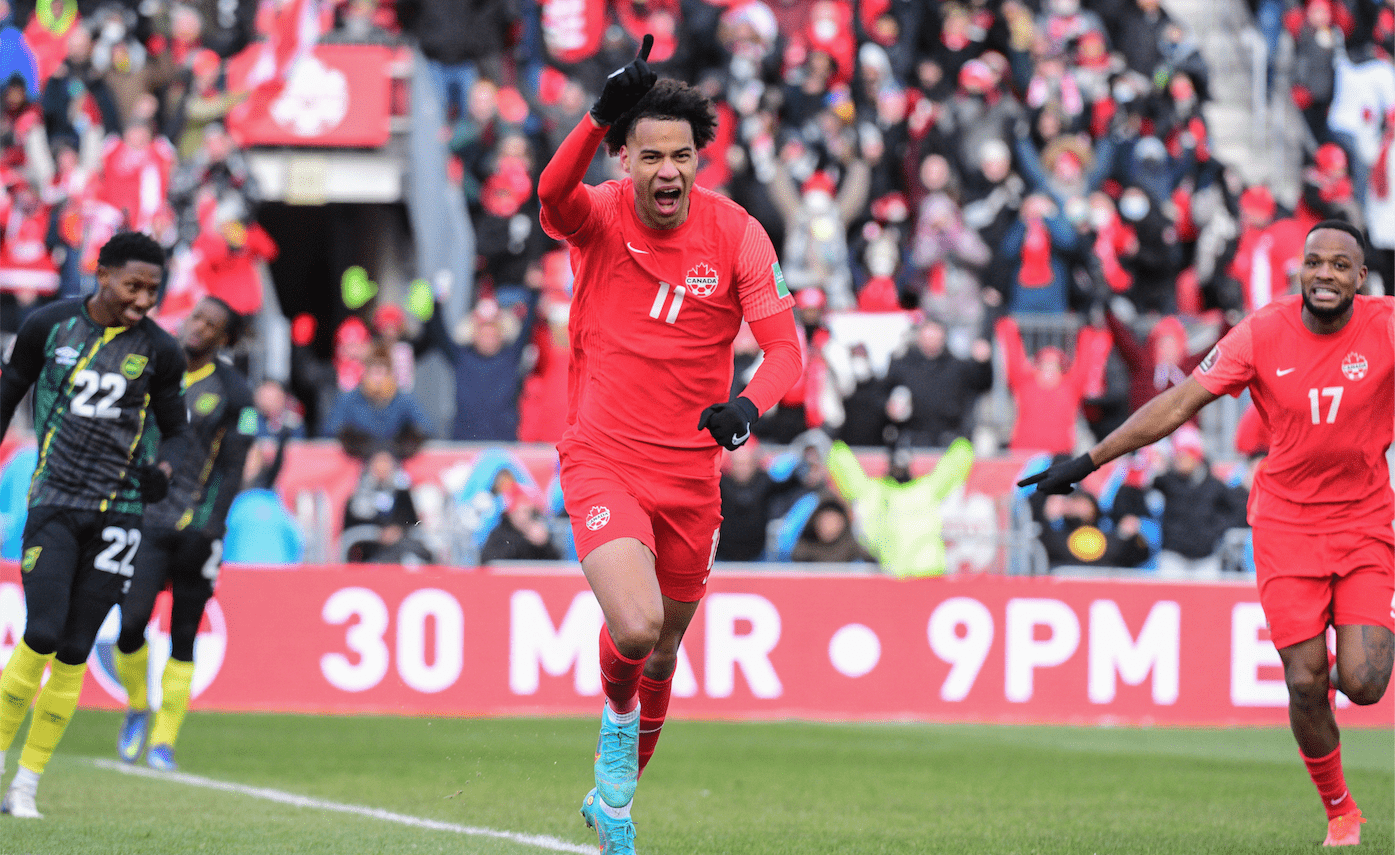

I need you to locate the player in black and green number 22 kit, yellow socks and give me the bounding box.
[0,232,188,819]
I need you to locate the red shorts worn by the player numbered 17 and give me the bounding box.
[1254,529,1395,649]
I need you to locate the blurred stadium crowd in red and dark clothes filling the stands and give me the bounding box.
[0,0,1395,573]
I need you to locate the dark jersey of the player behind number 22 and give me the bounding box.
[145,360,257,538]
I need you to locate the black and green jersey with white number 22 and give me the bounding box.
[0,300,188,513]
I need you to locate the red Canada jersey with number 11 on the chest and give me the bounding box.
[541,179,794,459]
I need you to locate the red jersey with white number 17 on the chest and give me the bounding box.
[1191,294,1395,531]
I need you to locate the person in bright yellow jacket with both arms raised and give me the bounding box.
[829,438,974,577]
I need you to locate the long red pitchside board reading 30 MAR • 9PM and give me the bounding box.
[0,563,1395,727]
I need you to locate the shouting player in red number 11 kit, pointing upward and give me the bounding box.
[538,35,802,855]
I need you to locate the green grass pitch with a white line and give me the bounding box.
[0,710,1395,855]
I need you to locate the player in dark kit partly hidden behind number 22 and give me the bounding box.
[116,297,257,771]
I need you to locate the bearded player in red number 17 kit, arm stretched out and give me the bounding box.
[1018,220,1395,847]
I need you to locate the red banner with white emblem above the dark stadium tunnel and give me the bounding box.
[227,45,399,148]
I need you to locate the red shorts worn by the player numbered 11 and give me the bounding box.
[557,441,721,603]
